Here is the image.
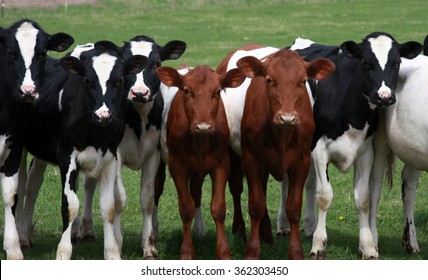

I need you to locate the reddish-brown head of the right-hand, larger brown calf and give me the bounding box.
[236,49,335,127]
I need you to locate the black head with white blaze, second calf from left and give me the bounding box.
[61,41,147,125]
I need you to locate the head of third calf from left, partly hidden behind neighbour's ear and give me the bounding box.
[123,36,186,103]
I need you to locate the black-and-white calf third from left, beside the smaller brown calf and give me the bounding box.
[82,36,186,259]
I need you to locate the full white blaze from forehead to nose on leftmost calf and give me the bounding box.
[15,22,39,90]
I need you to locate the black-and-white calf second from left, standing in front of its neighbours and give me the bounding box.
[25,41,147,259]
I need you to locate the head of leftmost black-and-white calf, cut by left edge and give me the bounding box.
[0,20,74,102]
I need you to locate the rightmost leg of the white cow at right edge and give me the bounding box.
[401,165,421,254]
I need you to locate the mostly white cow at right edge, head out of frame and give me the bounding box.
[370,36,428,253]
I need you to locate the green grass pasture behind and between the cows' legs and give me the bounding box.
[0,0,428,260]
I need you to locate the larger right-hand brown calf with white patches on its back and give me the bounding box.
[217,45,334,259]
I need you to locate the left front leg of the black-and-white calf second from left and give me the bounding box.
[56,152,79,260]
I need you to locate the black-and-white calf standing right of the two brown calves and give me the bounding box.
[292,32,421,259]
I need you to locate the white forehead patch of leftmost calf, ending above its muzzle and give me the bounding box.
[15,22,39,69]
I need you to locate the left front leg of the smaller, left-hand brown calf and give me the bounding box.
[168,161,195,260]
